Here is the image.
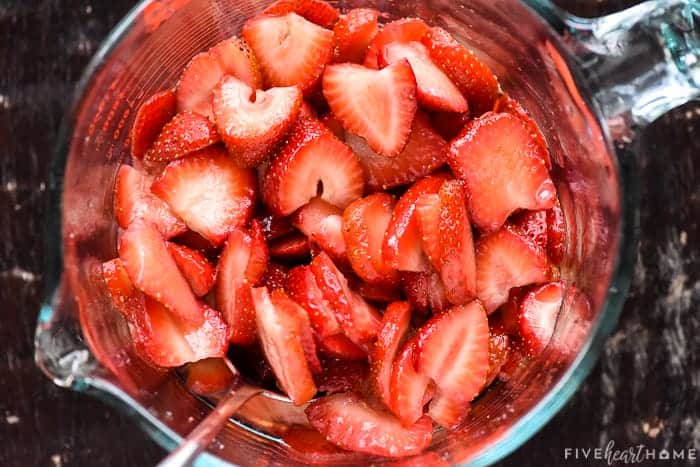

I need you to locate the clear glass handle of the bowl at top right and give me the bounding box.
[526,0,700,139]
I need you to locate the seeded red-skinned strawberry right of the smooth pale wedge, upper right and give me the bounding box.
[422,27,499,115]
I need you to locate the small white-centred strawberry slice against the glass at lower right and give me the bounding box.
[519,281,565,355]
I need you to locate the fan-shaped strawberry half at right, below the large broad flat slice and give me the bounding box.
[476,226,552,313]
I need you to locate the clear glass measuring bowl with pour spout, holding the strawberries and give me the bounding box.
[36,0,700,465]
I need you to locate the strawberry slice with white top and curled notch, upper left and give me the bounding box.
[212,76,302,167]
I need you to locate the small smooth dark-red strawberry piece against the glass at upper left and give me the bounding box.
[131,89,177,159]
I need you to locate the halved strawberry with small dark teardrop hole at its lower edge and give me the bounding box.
[263,119,364,216]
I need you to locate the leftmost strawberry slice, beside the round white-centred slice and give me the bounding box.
[114,165,187,238]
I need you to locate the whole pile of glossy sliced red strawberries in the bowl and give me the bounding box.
[103,0,592,456]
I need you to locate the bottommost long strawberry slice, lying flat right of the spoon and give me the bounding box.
[306,392,433,457]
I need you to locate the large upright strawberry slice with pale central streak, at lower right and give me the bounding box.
[416,301,489,403]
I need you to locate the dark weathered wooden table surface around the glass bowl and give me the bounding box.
[0,0,700,467]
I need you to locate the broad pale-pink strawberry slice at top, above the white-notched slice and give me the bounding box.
[243,13,334,95]
